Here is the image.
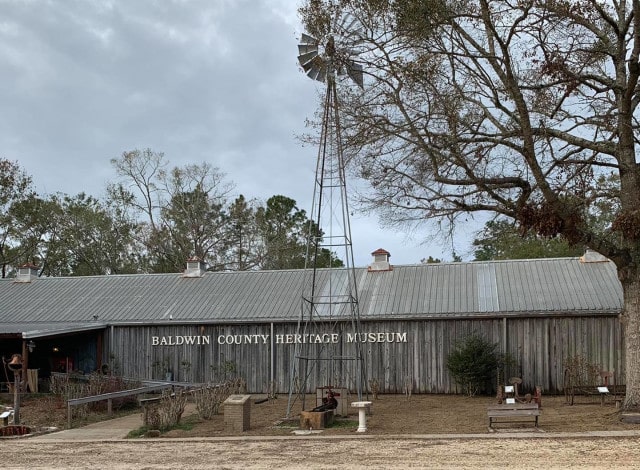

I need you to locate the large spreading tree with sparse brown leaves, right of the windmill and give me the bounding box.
[301,0,640,409]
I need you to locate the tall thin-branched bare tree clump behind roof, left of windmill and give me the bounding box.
[109,150,233,272]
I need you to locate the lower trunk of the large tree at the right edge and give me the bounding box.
[622,274,640,410]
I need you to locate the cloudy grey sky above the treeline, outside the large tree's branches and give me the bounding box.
[0,0,476,266]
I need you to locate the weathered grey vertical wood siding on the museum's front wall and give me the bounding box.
[104,316,624,393]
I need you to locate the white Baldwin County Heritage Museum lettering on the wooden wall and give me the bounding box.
[151,332,407,346]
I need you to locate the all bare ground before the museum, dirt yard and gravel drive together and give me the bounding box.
[5,395,640,470]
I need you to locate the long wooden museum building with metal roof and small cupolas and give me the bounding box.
[0,249,624,393]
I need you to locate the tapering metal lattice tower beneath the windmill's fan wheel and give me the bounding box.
[287,76,366,416]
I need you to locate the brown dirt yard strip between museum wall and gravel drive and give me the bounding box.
[11,395,640,438]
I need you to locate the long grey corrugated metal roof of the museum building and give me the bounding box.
[0,258,622,333]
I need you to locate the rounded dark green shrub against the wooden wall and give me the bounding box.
[446,335,506,396]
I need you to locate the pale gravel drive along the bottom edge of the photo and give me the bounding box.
[5,436,640,470]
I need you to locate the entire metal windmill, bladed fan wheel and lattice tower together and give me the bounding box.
[287,11,366,415]
